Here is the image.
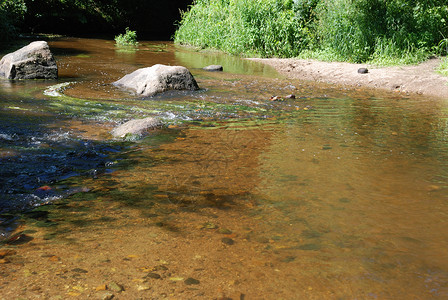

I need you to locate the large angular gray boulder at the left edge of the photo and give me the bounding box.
[0,41,58,79]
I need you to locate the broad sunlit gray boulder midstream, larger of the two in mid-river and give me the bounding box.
[113,65,199,97]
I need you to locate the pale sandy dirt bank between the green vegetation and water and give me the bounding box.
[251,58,448,99]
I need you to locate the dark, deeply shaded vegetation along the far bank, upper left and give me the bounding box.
[0,0,188,40]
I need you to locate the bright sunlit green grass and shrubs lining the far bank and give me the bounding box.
[175,0,448,64]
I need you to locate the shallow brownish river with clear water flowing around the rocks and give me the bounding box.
[0,38,448,299]
